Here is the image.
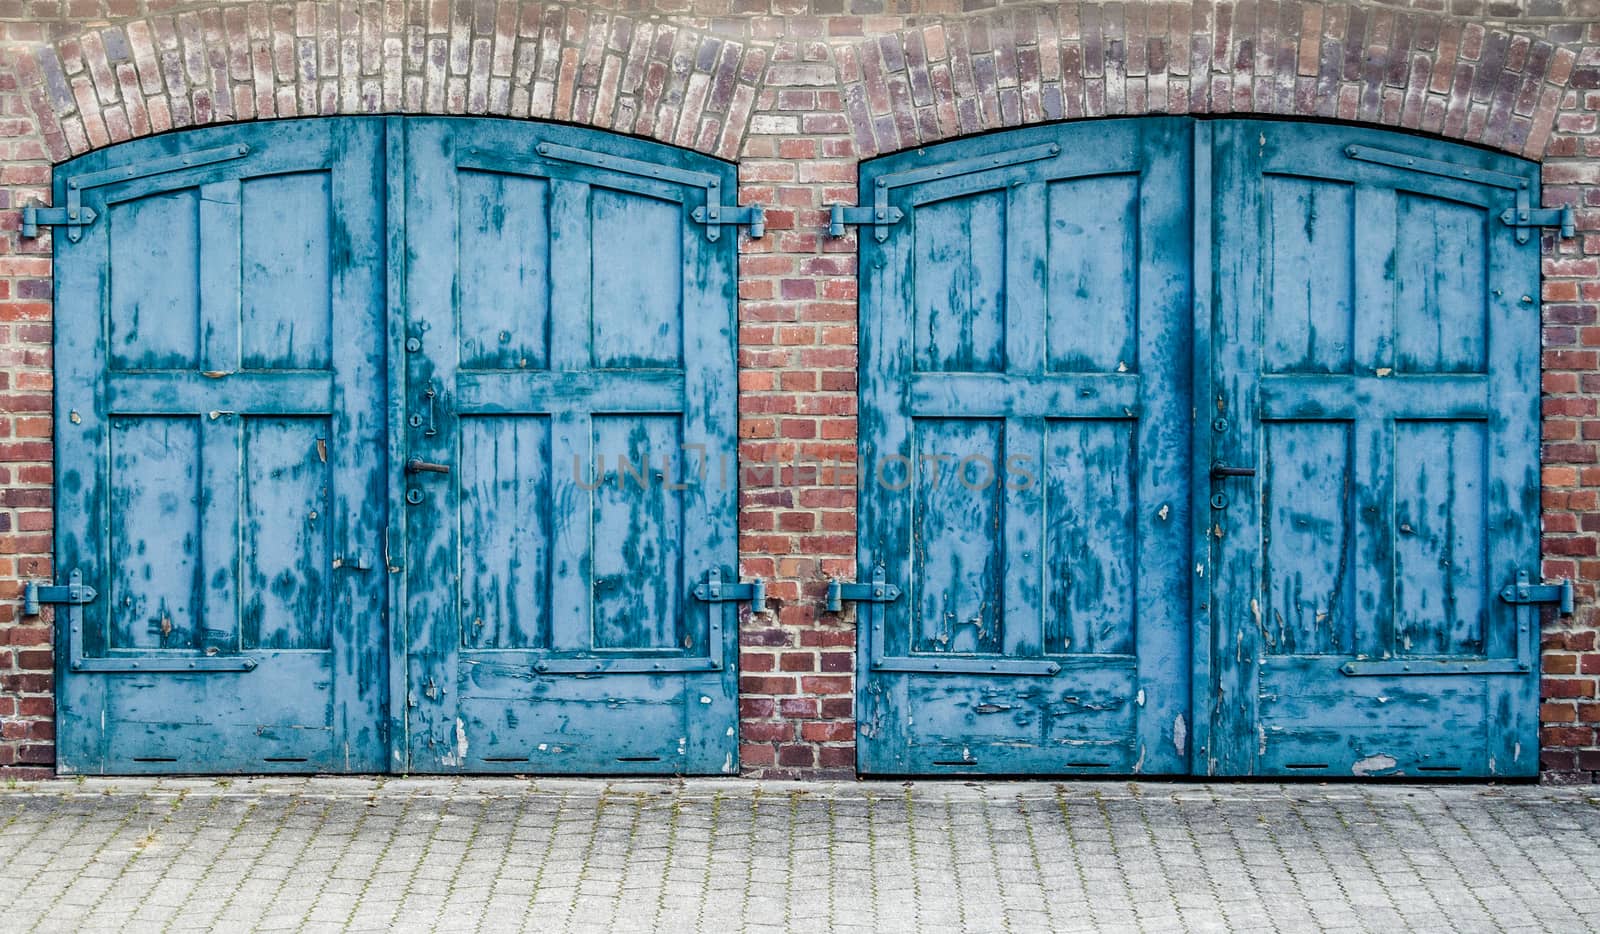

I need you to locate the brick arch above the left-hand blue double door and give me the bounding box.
[18,0,768,163]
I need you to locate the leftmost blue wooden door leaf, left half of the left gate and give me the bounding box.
[56,120,387,772]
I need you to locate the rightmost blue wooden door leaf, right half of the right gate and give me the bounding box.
[1197,122,1539,777]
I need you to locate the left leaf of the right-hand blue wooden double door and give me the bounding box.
[858,118,1194,774]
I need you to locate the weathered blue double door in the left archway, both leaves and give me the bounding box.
[56,118,738,772]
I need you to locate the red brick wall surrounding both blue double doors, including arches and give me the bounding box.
[0,0,1600,780]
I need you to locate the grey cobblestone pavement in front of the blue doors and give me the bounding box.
[0,779,1600,934]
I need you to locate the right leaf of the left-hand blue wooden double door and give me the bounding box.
[402,118,738,772]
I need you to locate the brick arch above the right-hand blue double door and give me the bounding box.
[837,0,1595,160]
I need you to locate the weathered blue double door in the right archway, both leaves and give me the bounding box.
[858,118,1539,776]
